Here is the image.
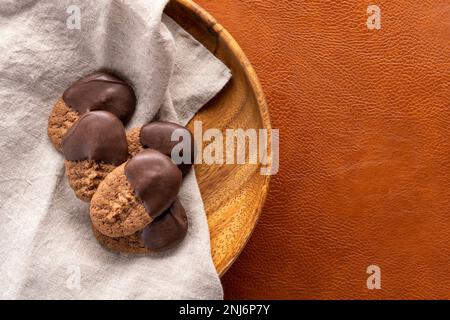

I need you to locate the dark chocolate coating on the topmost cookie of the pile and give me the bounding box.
[63,72,136,123]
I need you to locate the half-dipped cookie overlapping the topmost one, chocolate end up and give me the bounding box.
[62,111,128,202]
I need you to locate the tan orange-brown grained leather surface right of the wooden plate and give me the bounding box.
[197,0,450,299]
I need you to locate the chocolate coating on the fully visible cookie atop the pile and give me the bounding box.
[125,149,182,218]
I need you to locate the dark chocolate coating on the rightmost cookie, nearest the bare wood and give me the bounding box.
[139,121,195,175]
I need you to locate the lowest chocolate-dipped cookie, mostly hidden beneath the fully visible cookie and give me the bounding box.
[92,200,188,253]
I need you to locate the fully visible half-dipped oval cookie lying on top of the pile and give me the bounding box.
[90,149,181,238]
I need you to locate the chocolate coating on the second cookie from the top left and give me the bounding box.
[62,111,128,166]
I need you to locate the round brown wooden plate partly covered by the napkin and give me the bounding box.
[165,0,270,275]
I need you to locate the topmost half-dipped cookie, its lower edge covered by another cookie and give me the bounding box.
[47,72,136,151]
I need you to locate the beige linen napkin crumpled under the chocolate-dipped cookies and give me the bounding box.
[0,0,230,299]
